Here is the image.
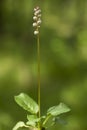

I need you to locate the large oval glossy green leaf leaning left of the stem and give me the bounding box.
[15,93,39,114]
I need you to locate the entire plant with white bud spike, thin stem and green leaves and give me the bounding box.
[13,6,70,130]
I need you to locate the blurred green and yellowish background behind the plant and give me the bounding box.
[0,0,87,130]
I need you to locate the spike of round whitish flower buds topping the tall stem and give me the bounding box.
[33,6,41,35]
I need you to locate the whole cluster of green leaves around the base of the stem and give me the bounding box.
[13,93,70,130]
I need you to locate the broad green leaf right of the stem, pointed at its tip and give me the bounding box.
[47,103,70,116]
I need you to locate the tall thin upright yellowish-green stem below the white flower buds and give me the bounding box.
[37,34,41,118]
